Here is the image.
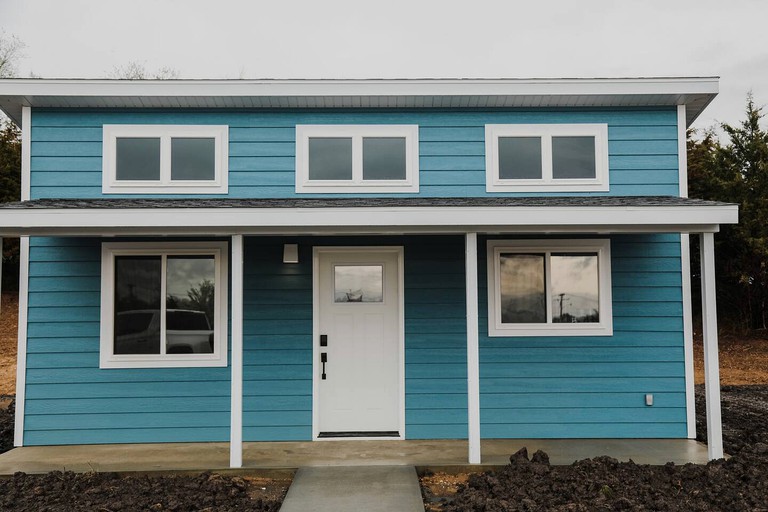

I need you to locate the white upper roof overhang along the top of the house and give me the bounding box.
[0,77,719,125]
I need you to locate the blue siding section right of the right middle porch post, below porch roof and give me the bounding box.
[479,235,686,438]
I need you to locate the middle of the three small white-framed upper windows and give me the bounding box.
[296,125,419,193]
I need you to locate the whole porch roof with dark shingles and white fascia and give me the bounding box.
[0,196,738,236]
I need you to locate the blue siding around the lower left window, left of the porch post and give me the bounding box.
[24,238,230,445]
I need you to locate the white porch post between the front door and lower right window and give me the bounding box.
[465,233,481,464]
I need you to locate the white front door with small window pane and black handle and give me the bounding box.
[314,247,404,438]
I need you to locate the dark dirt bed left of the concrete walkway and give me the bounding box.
[0,471,287,512]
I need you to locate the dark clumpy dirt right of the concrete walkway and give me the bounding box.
[425,386,768,512]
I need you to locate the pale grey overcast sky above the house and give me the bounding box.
[0,0,768,127]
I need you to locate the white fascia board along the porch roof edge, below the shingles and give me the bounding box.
[0,205,738,236]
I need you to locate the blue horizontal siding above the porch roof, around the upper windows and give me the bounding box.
[31,108,678,199]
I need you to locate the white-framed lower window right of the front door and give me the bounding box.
[488,239,613,336]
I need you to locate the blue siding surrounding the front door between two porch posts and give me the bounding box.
[243,236,467,441]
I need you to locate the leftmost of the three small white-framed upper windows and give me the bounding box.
[102,124,228,194]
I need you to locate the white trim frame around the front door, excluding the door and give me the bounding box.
[312,245,405,441]
